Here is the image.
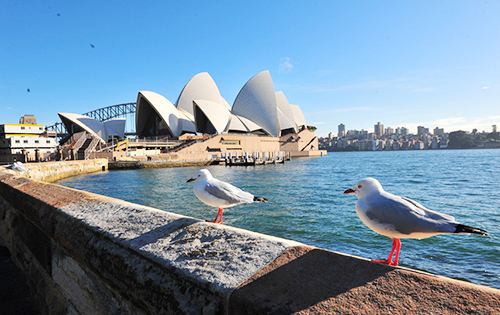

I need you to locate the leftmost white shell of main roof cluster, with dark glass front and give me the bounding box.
[135,91,188,137]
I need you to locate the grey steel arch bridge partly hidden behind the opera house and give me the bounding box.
[47,103,136,137]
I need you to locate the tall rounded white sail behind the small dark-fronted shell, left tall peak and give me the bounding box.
[176,72,229,116]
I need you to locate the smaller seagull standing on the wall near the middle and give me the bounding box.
[187,169,268,223]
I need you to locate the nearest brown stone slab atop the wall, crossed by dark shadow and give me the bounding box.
[229,246,500,314]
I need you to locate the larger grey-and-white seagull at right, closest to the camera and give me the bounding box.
[344,177,488,266]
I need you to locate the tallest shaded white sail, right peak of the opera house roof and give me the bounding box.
[232,70,280,137]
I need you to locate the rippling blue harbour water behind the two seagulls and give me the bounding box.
[59,150,500,288]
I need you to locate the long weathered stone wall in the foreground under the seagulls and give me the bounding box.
[0,171,500,314]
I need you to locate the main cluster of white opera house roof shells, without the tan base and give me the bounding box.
[136,71,306,137]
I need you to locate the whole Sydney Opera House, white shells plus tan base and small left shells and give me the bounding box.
[59,71,323,159]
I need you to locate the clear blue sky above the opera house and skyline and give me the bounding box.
[0,0,500,135]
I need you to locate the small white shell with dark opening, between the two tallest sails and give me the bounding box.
[194,100,231,134]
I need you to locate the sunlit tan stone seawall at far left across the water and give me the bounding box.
[24,159,108,182]
